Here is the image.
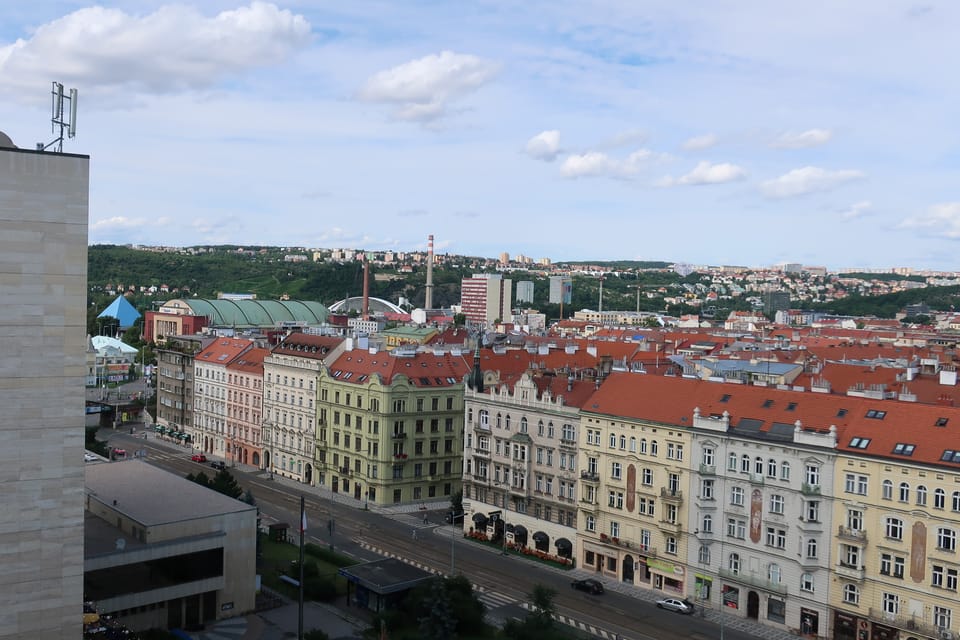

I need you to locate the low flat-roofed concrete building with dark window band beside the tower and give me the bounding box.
[85,459,257,637]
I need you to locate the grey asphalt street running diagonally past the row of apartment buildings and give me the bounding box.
[92,427,756,640]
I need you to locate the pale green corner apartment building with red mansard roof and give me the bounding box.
[317,346,470,505]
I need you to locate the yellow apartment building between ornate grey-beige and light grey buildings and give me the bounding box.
[577,372,692,596]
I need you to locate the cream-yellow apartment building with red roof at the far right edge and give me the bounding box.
[830,398,960,640]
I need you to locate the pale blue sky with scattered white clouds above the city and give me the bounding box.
[0,0,960,271]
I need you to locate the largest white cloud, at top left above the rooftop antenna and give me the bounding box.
[0,2,310,101]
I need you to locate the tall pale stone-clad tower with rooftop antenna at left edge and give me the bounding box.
[0,132,90,638]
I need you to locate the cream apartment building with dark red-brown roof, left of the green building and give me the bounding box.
[263,333,346,485]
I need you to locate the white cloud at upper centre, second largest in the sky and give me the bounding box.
[358,51,499,122]
